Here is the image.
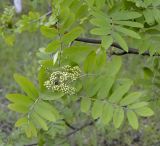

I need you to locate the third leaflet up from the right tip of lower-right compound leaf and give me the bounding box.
[120,92,142,106]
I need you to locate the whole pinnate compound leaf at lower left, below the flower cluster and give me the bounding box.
[6,74,59,137]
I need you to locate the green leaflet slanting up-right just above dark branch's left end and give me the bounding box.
[62,27,83,44]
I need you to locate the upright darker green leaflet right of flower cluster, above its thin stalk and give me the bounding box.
[84,51,96,73]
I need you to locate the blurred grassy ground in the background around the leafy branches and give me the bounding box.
[0,0,160,146]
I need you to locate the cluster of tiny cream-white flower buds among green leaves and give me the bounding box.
[44,65,81,95]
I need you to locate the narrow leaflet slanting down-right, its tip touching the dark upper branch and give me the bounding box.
[113,32,128,52]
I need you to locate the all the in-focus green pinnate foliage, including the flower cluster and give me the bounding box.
[0,0,160,145]
